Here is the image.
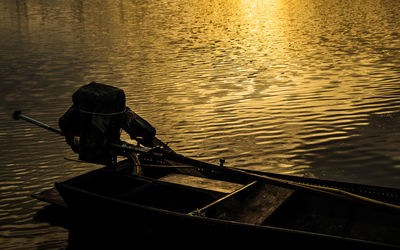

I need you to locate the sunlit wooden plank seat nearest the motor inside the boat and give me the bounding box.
[159,174,243,194]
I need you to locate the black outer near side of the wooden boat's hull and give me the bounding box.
[56,168,396,249]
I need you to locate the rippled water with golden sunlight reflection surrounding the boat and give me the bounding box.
[0,0,400,249]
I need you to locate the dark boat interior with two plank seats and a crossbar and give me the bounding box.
[57,165,400,243]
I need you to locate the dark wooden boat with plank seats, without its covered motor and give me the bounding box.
[33,141,400,249]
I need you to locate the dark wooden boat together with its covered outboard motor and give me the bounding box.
[13,83,400,246]
